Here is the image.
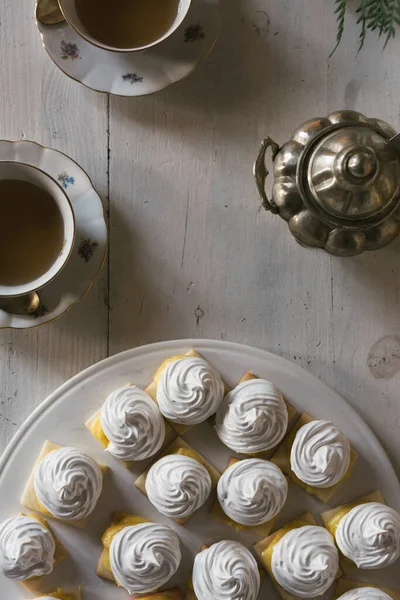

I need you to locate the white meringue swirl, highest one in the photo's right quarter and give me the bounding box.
[290,421,351,488]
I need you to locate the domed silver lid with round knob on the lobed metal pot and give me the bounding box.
[304,121,400,229]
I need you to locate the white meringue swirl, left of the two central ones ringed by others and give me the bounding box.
[146,454,211,519]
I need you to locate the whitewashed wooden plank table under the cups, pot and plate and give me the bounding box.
[0,0,400,474]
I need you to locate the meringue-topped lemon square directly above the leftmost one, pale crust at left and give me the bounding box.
[21,442,106,527]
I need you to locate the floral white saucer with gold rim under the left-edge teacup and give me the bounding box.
[0,140,107,329]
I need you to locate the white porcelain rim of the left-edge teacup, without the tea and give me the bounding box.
[0,162,75,298]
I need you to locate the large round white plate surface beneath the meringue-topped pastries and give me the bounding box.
[0,340,400,600]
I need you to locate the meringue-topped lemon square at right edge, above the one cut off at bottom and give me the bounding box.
[322,492,400,570]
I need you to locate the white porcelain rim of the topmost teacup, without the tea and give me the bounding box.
[58,0,192,52]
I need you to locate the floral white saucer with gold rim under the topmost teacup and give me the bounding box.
[36,0,220,96]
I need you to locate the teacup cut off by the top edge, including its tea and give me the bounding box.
[58,0,192,52]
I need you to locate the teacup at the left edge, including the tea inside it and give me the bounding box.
[0,161,75,299]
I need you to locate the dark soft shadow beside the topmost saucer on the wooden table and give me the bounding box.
[112,0,301,137]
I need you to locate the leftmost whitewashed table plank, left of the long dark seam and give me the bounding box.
[0,0,108,451]
